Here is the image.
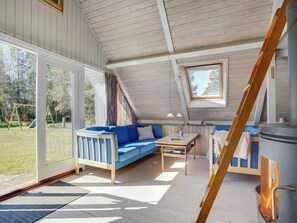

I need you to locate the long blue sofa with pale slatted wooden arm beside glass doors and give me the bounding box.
[76,124,162,183]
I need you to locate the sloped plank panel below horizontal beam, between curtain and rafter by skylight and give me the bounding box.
[116,62,181,120]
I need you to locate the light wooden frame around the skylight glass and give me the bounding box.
[185,63,225,100]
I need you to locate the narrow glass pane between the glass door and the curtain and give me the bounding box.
[84,69,106,126]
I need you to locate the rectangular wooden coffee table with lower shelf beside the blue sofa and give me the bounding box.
[155,133,199,175]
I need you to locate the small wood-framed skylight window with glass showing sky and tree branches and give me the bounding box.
[187,64,223,99]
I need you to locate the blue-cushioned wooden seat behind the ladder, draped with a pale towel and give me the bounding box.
[209,125,260,175]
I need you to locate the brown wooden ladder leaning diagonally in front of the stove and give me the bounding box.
[196,0,289,223]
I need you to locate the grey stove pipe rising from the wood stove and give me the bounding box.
[287,0,297,127]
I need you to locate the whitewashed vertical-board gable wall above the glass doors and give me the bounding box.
[0,0,106,69]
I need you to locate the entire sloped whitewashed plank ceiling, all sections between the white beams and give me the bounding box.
[79,0,273,120]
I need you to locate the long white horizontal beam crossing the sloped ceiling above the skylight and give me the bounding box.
[107,40,263,69]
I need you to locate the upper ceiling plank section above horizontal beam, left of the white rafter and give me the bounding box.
[79,0,167,61]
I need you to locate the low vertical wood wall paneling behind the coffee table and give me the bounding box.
[162,125,214,156]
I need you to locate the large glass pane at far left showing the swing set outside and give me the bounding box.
[0,42,36,194]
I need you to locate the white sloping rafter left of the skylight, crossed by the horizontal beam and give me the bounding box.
[156,0,189,120]
